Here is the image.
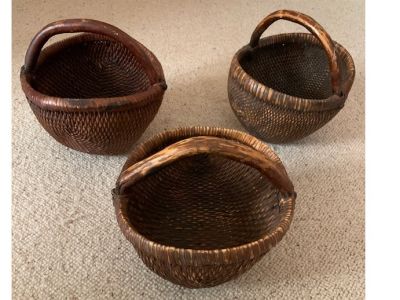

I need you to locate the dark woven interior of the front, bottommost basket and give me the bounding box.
[126,154,283,249]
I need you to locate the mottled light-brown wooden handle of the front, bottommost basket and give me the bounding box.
[116,136,294,194]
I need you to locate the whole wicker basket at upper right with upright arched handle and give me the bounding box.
[228,10,355,143]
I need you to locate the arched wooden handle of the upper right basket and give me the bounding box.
[250,10,341,95]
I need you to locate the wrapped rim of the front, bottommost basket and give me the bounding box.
[112,126,296,266]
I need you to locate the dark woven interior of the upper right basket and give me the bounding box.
[239,40,346,99]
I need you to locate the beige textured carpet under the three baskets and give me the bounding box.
[12,0,364,299]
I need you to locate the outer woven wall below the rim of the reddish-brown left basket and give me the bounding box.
[29,98,161,154]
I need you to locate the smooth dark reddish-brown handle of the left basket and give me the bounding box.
[25,19,159,84]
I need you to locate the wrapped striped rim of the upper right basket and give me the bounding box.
[229,32,355,111]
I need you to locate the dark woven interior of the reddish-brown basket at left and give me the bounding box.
[31,35,150,99]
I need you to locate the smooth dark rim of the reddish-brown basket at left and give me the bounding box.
[20,33,167,112]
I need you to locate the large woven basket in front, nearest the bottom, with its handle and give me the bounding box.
[113,127,296,288]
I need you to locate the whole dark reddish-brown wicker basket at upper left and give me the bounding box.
[20,19,167,154]
